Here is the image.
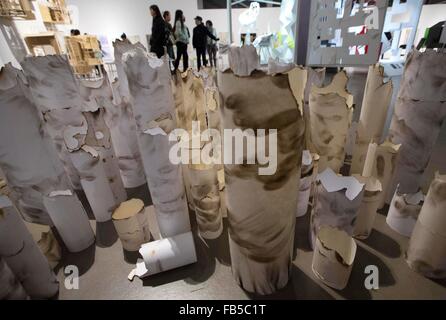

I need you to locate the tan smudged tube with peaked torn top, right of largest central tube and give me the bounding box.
[310,71,353,173]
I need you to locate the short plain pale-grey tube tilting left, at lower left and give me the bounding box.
[43,190,95,253]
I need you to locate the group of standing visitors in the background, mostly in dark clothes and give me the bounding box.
[150,5,220,71]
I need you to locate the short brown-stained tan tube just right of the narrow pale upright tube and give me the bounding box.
[373,141,401,209]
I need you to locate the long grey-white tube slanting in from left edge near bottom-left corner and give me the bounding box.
[0,195,59,299]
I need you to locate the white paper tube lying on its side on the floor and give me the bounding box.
[128,232,197,281]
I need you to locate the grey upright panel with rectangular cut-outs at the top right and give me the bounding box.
[307,0,388,66]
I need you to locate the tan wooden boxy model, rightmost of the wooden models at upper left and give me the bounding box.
[65,35,102,75]
